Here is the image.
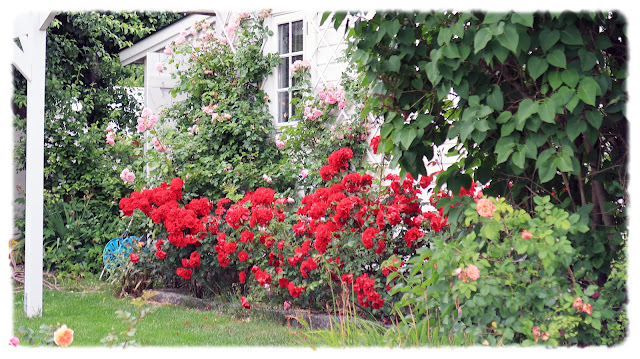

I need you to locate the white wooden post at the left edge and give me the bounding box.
[13,13,55,317]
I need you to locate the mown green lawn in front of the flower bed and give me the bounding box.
[13,281,299,347]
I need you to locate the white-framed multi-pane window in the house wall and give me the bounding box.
[276,20,304,124]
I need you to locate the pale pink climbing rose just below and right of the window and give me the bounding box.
[279,60,374,191]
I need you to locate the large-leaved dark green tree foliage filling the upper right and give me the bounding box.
[333,12,629,346]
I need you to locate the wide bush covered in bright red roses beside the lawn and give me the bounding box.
[120,148,474,313]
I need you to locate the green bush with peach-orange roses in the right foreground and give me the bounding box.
[380,197,605,346]
